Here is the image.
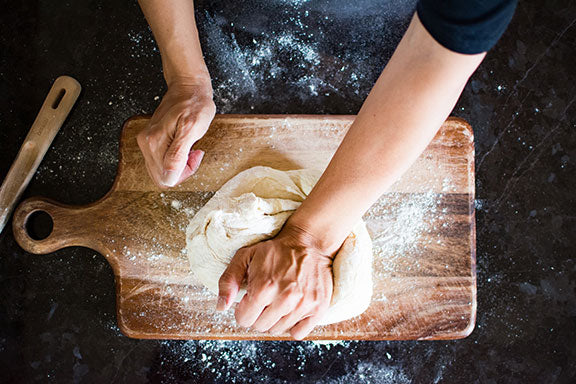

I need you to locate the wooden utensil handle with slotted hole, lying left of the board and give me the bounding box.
[0,76,82,233]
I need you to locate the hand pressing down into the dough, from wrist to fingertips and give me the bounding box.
[217,223,333,340]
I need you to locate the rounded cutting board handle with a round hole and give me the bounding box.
[12,197,87,254]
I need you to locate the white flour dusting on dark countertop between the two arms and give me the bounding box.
[202,0,372,113]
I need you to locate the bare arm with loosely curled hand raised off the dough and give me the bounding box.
[138,0,216,186]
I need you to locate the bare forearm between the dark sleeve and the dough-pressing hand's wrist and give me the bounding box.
[287,17,484,253]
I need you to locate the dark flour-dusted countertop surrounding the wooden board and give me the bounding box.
[0,0,576,383]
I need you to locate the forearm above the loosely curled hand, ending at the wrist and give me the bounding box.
[138,0,210,85]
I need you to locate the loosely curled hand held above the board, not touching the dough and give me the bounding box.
[137,78,216,187]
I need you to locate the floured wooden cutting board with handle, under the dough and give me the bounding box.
[13,115,476,340]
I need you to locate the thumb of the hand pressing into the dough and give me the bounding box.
[216,248,252,311]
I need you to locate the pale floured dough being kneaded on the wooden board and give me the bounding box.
[186,167,372,324]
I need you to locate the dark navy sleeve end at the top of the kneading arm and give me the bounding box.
[416,0,517,54]
